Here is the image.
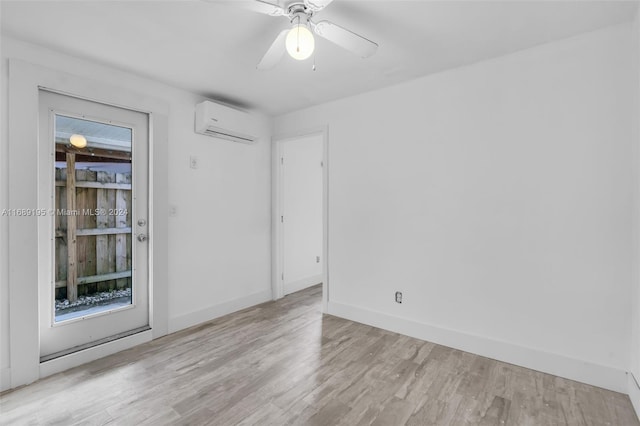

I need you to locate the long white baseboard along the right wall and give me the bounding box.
[328,301,629,394]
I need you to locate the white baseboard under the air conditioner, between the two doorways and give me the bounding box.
[169,290,272,333]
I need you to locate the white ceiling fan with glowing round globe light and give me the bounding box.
[250,0,378,70]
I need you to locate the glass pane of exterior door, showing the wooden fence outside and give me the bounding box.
[54,113,133,323]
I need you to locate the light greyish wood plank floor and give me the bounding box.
[0,286,640,426]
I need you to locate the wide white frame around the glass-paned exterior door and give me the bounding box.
[7,59,169,388]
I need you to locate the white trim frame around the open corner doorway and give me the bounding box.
[271,126,330,313]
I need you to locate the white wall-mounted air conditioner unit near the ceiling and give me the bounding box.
[196,101,258,143]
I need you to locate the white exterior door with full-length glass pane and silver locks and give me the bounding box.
[36,90,149,361]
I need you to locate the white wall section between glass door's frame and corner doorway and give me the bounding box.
[169,96,271,331]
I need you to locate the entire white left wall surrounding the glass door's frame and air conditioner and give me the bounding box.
[0,37,272,389]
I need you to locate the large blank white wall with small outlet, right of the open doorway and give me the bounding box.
[274,21,635,392]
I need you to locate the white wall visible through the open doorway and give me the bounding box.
[280,134,323,294]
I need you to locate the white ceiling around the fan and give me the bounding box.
[0,0,638,115]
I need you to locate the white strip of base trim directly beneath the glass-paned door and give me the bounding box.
[40,330,152,378]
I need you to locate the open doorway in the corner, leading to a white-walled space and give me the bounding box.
[274,131,327,307]
